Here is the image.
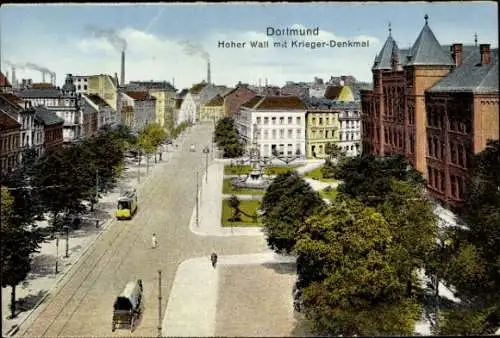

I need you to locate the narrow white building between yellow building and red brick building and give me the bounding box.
[336,101,361,156]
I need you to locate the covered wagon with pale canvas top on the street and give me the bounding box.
[111,279,142,332]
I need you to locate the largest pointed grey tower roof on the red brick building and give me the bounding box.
[406,15,454,66]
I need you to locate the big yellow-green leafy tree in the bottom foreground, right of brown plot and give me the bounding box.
[294,198,421,336]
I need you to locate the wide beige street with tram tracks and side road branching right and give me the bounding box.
[19,125,266,336]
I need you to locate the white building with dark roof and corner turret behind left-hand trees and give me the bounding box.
[15,74,83,144]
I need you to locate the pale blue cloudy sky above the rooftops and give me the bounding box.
[0,2,498,89]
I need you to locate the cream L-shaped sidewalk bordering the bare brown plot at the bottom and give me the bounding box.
[162,251,296,337]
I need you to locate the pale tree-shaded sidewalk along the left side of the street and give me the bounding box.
[2,134,189,337]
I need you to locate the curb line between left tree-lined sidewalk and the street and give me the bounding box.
[9,160,169,337]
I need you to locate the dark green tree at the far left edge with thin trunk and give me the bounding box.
[0,186,41,318]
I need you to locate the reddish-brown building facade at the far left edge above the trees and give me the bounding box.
[0,108,22,177]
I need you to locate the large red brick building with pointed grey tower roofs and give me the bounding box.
[361,16,499,206]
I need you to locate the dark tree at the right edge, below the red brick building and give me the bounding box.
[440,140,500,334]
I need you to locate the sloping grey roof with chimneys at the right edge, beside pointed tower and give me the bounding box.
[428,46,498,93]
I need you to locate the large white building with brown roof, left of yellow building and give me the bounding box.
[235,96,306,157]
